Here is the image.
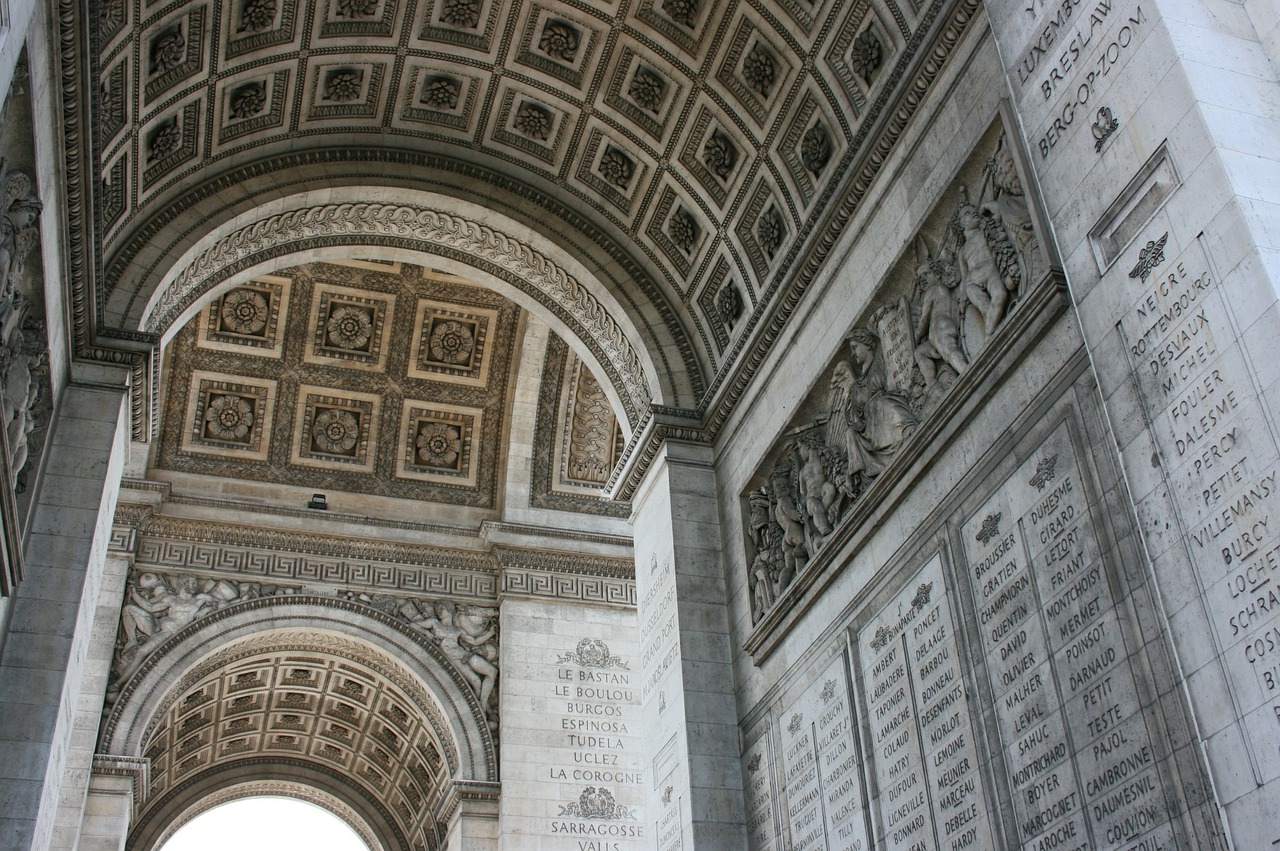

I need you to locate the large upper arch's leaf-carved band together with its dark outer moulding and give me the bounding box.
[116,175,709,414]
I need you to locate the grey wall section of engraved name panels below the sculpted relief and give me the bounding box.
[742,401,1202,851]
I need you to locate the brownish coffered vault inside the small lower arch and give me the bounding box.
[134,633,458,851]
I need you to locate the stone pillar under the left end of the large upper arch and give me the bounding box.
[0,365,128,851]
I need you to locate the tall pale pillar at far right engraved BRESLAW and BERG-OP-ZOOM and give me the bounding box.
[987,0,1280,847]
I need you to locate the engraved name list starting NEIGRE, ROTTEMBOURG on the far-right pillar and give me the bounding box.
[1120,244,1280,782]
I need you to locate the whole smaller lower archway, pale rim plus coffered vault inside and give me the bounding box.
[100,595,497,851]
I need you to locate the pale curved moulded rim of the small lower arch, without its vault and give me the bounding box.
[99,595,498,781]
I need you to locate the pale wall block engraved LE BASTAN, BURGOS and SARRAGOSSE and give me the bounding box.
[499,599,652,851]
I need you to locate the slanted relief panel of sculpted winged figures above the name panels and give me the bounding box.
[744,124,1048,623]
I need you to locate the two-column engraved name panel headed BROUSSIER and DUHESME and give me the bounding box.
[963,425,1174,848]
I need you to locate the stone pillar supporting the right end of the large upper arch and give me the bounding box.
[634,438,746,851]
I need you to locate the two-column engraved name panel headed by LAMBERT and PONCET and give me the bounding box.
[858,557,995,851]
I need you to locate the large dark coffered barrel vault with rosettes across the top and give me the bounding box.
[74,0,974,422]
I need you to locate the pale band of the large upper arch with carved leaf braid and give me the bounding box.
[114,188,700,440]
